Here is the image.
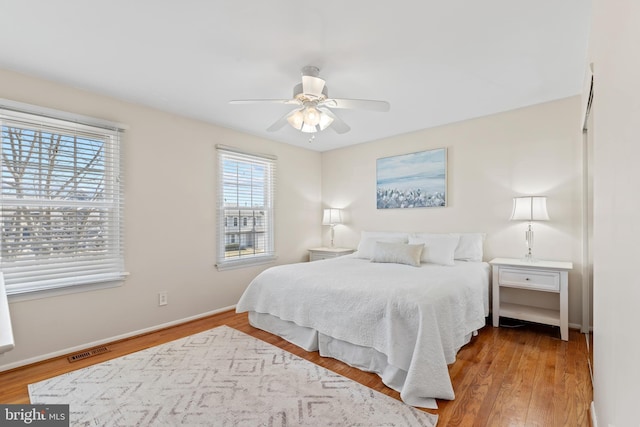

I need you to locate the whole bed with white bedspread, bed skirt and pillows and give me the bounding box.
[236,232,490,408]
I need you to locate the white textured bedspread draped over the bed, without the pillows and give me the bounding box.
[236,256,489,406]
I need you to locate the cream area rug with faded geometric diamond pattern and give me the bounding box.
[29,326,437,427]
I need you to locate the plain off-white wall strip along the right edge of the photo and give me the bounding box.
[590,0,640,427]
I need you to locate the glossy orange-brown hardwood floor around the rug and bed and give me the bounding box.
[0,311,593,427]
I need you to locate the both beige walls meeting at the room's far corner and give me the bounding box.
[0,67,592,369]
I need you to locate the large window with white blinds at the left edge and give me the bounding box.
[0,101,125,295]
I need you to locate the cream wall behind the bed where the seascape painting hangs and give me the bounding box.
[322,96,582,326]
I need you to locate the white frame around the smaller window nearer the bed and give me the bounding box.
[216,144,277,271]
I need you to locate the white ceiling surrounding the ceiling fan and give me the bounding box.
[0,0,591,151]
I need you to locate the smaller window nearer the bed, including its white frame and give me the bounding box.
[217,146,276,270]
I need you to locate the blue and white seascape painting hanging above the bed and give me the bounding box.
[376,148,447,209]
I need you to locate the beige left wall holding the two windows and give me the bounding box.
[0,70,321,370]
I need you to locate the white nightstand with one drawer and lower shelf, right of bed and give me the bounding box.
[489,258,573,341]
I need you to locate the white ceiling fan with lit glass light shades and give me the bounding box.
[230,66,390,134]
